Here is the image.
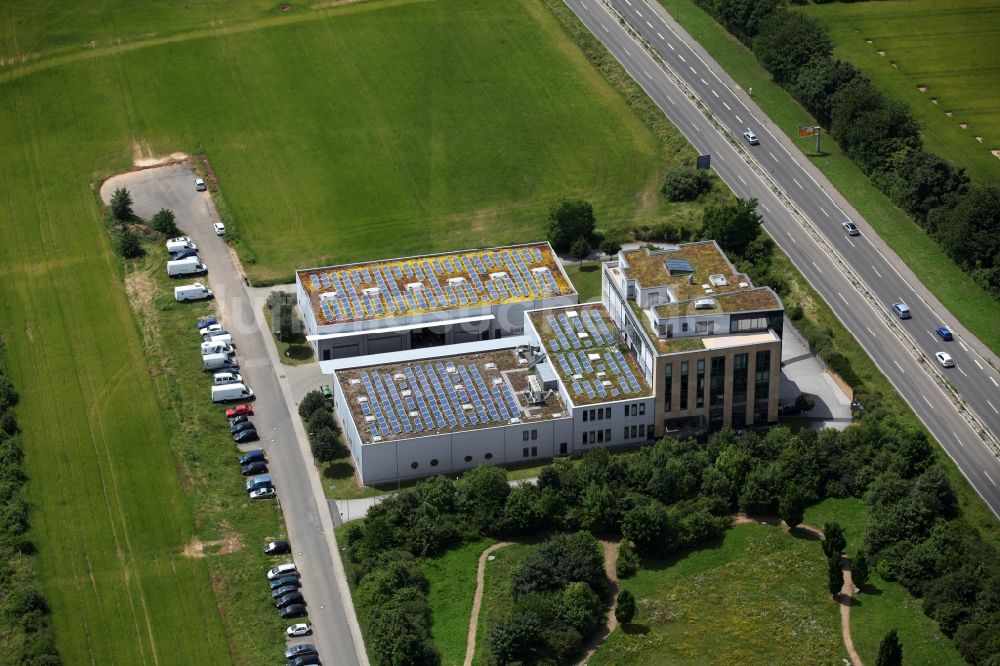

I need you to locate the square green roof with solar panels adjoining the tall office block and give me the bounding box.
[528,303,651,405]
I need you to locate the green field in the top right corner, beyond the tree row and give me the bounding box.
[799,0,1000,183]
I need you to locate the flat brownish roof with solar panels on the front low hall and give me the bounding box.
[337,350,567,444]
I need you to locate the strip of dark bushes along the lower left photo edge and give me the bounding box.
[0,340,62,666]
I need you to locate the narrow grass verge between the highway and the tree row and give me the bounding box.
[660,0,1000,354]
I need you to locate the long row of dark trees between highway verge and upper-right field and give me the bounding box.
[696,0,1000,297]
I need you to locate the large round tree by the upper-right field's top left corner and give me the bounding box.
[753,10,833,83]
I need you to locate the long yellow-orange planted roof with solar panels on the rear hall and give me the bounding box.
[297,243,576,326]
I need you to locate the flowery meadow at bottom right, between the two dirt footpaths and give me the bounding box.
[590,524,845,666]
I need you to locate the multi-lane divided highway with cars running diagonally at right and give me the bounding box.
[564,0,1000,516]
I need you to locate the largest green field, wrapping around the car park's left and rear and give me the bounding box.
[0,0,662,664]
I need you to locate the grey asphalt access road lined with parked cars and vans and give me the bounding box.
[101,164,368,666]
